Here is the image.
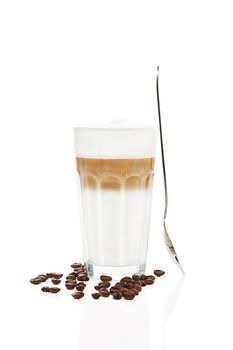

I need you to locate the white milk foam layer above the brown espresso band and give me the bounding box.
[74,128,157,159]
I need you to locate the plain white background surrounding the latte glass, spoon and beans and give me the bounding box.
[0,0,233,350]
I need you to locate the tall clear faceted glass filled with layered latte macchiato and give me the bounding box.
[74,127,157,277]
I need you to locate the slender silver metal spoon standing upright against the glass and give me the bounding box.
[156,66,184,274]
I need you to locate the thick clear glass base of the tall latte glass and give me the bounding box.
[85,261,146,279]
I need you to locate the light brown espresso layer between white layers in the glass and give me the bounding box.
[76,157,154,191]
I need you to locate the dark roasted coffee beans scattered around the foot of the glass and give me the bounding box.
[30,263,165,300]
